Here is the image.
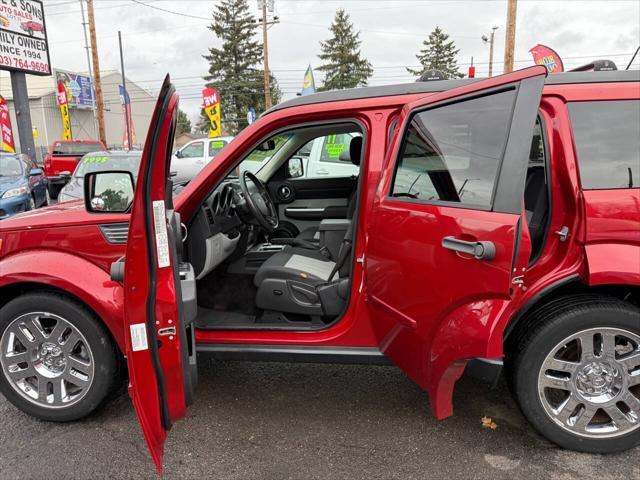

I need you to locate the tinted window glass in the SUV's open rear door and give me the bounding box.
[391,90,516,208]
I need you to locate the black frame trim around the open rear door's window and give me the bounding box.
[385,81,520,212]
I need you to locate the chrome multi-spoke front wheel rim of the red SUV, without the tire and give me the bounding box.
[0,312,94,408]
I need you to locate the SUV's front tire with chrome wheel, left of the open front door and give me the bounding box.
[0,292,118,422]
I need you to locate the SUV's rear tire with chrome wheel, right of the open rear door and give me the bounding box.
[508,295,640,453]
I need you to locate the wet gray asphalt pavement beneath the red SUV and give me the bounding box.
[0,357,640,480]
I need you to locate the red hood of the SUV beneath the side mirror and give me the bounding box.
[0,200,129,232]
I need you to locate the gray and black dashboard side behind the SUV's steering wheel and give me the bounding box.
[187,181,246,280]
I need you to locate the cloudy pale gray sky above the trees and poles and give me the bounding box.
[33,0,640,118]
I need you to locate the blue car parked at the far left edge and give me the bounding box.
[0,153,49,220]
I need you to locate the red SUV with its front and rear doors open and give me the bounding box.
[0,66,640,468]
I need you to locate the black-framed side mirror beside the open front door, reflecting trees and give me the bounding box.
[84,171,134,213]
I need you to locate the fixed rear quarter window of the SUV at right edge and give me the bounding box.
[569,100,640,190]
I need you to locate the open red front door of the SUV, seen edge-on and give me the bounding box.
[124,76,196,472]
